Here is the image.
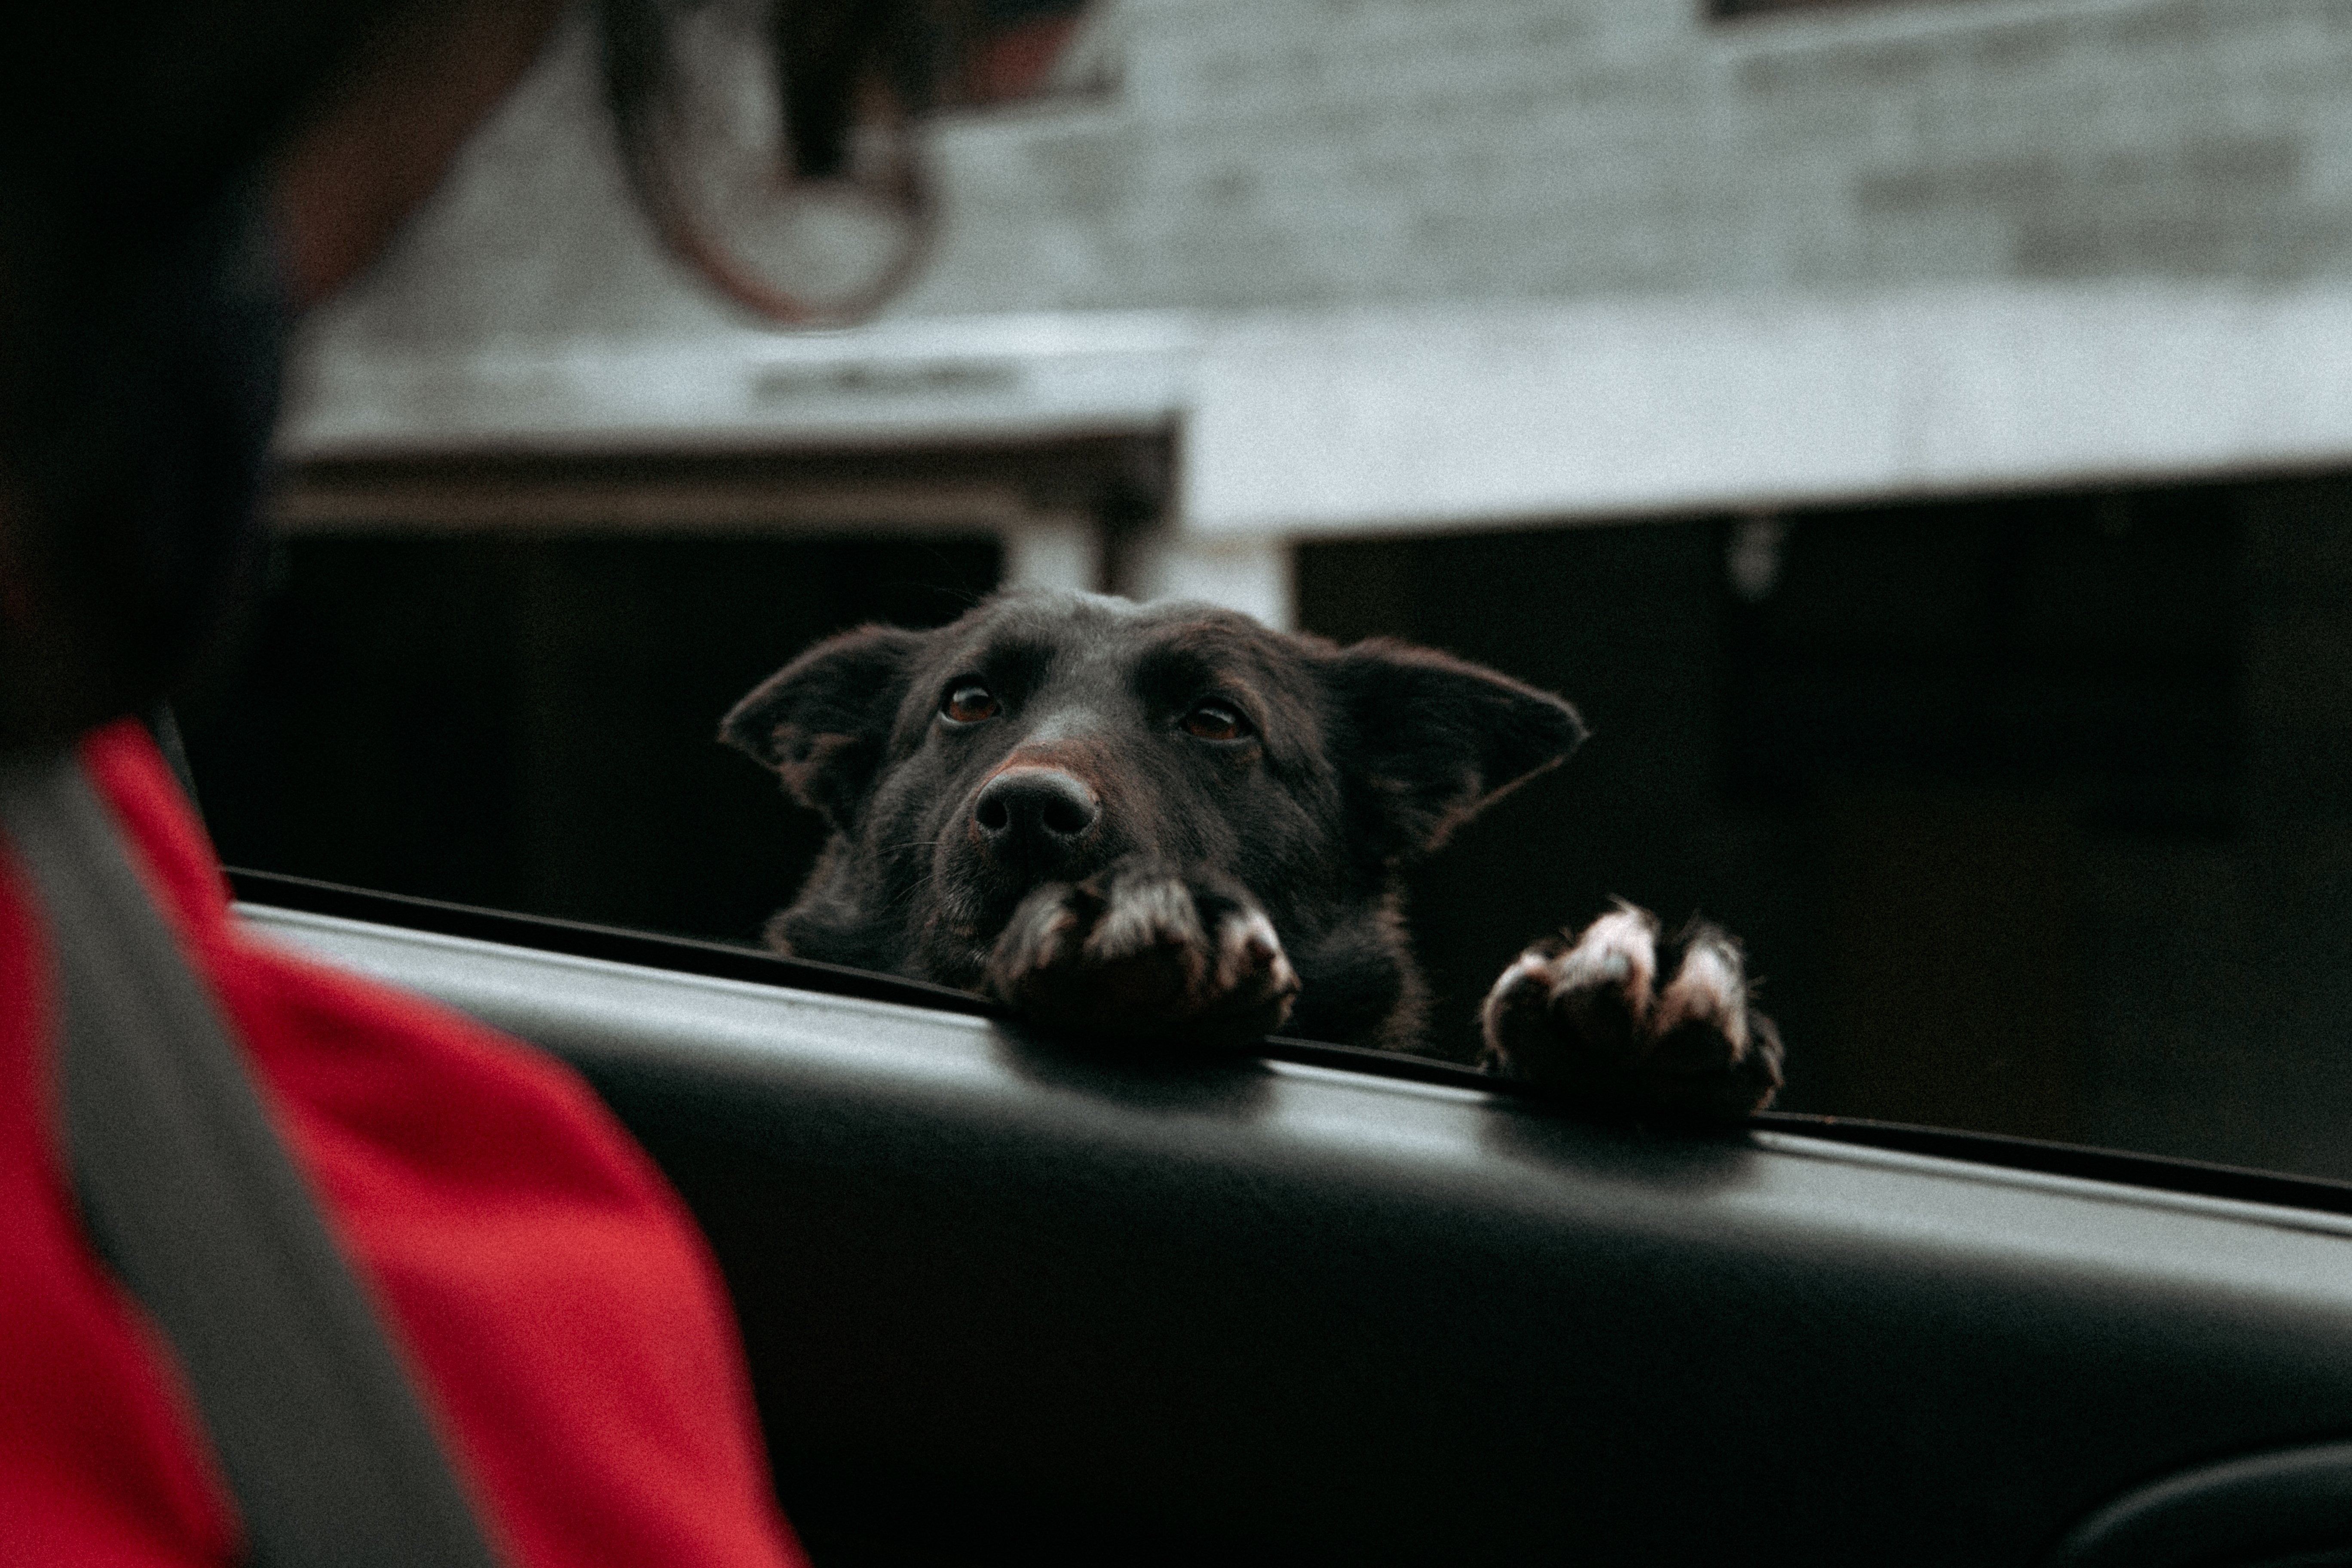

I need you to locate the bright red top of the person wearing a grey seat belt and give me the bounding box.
[0,724,804,1568]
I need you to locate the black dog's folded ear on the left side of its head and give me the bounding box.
[720,625,927,830]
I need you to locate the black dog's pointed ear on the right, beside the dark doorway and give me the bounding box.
[1324,640,1585,865]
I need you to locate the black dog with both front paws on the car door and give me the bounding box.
[720,595,1780,1119]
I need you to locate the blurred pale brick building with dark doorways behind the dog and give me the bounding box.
[190,0,2352,1176]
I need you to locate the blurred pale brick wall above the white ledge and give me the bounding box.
[317,0,2352,346]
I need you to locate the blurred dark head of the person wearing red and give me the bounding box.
[0,0,553,750]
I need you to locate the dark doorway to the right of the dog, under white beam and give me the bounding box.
[1298,480,2352,1176]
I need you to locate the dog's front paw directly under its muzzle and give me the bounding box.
[983,861,1298,1046]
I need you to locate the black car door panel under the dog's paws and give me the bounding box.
[247,907,2352,1563]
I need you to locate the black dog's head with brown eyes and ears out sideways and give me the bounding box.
[720,595,1583,980]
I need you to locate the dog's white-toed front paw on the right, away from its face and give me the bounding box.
[1484,905,1780,1121]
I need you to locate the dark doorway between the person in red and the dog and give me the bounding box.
[186,536,1000,943]
